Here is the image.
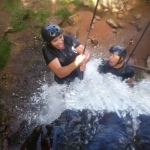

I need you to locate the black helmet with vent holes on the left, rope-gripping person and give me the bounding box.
[41,24,63,42]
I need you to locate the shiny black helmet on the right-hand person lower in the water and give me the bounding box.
[109,46,127,58]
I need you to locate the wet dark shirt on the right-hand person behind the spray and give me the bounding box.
[98,60,135,81]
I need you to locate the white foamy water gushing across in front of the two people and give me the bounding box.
[28,59,150,127]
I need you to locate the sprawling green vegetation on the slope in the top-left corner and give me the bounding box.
[4,0,50,32]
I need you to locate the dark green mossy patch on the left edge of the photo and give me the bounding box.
[0,37,11,69]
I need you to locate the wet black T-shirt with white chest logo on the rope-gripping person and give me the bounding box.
[42,35,80,84]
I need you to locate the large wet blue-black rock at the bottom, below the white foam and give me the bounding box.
[20,110,133,150]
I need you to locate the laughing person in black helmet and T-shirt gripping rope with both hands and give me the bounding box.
[41,24,91,84]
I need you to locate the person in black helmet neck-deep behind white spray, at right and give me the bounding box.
[98,46,135,84]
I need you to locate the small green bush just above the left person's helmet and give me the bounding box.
[54,7,72,19]
